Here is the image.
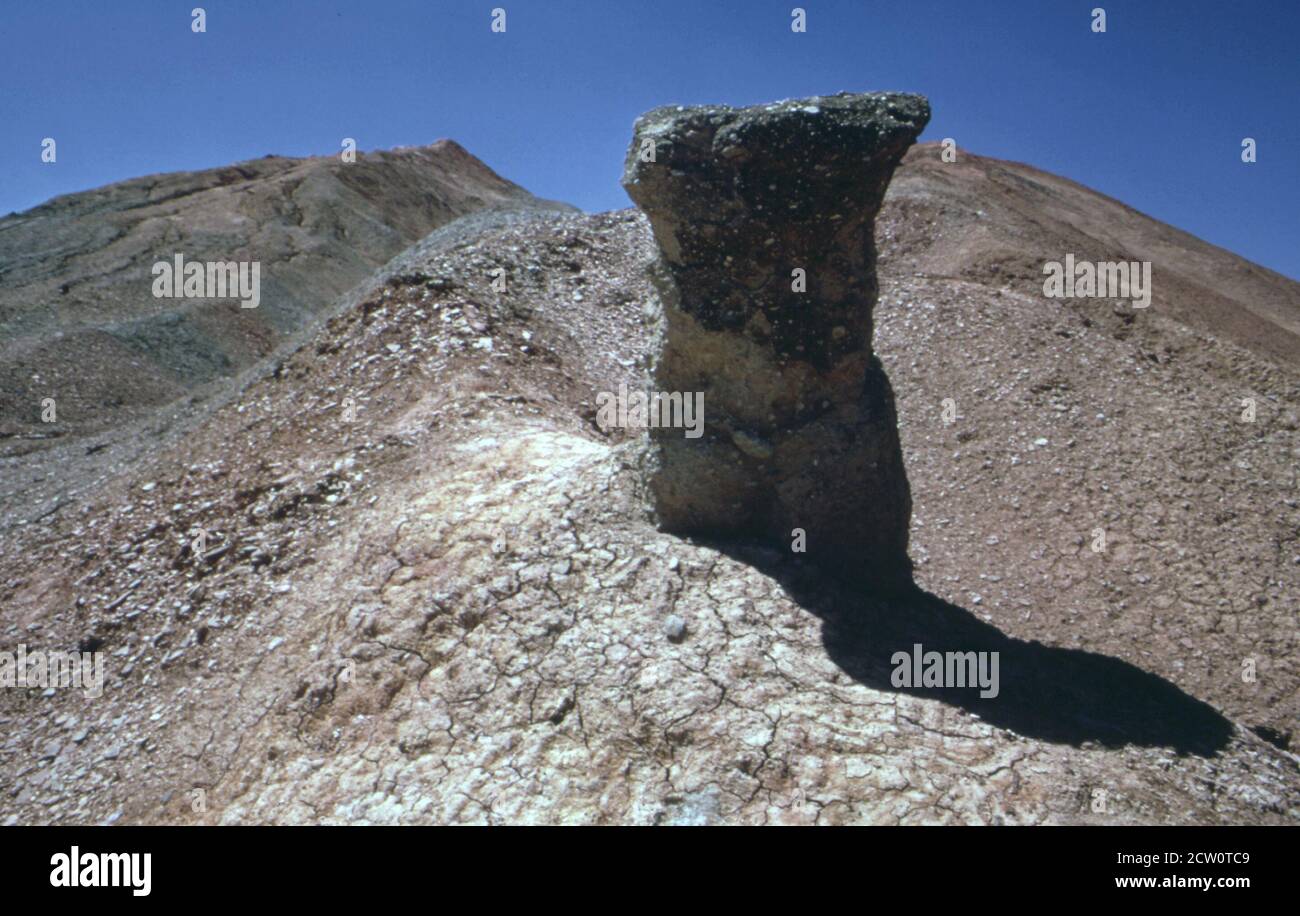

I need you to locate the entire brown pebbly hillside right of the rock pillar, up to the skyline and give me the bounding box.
[876,144,1300,734]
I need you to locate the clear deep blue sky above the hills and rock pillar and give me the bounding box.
[0,0,1300,278]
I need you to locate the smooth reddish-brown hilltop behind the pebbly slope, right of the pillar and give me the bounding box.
[891,143,1300,369]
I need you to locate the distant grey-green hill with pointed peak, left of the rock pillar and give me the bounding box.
[0,140,559,437]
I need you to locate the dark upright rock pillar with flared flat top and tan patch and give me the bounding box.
[623,94,930,583]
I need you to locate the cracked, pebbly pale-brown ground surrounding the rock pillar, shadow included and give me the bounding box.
[0,140,1300,824]
